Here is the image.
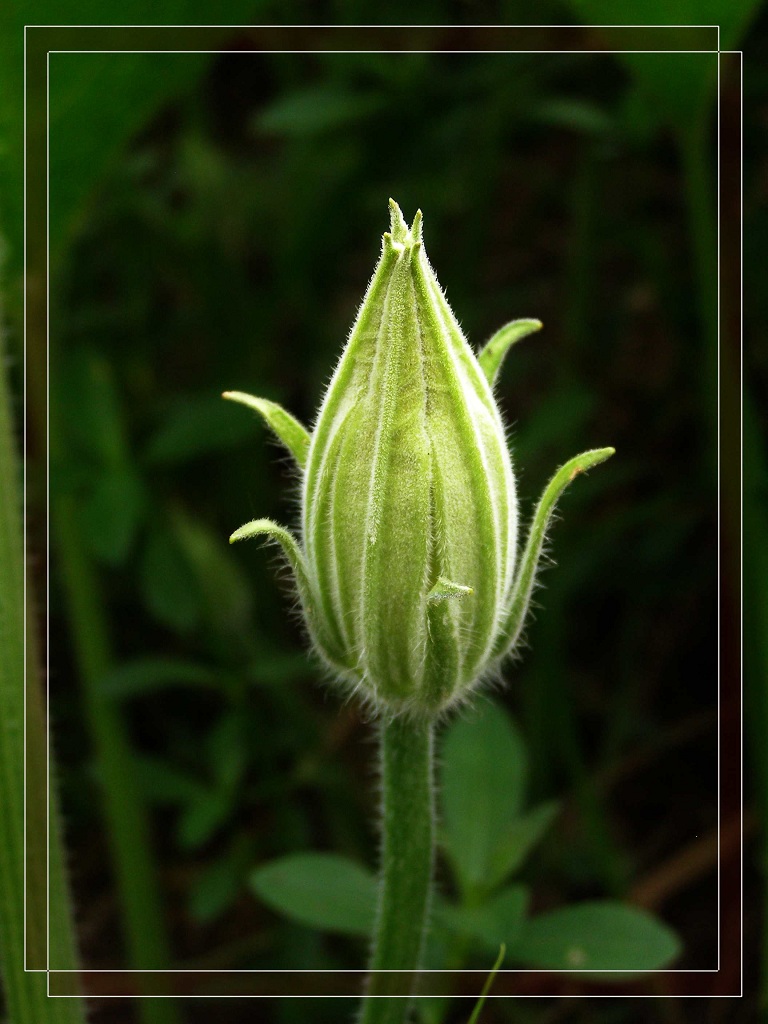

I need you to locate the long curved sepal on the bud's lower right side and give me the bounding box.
[494,447,615,657]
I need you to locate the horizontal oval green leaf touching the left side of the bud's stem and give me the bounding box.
[251,853,376,935]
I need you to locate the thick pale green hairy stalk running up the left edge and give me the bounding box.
[0,331,85,1024]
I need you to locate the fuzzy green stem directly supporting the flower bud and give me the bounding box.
[360,716,435,1024]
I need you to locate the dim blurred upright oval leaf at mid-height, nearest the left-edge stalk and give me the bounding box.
[80,468,146,565]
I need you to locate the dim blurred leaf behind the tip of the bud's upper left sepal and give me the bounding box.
[146,394,259,464]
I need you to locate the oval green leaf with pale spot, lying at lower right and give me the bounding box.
[510,900,681,978]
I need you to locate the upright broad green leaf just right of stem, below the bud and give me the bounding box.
[441,703,526,892]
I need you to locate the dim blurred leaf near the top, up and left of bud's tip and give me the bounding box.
[254,85,383,136]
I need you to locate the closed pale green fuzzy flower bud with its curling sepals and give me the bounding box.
[226,195,612,714]
